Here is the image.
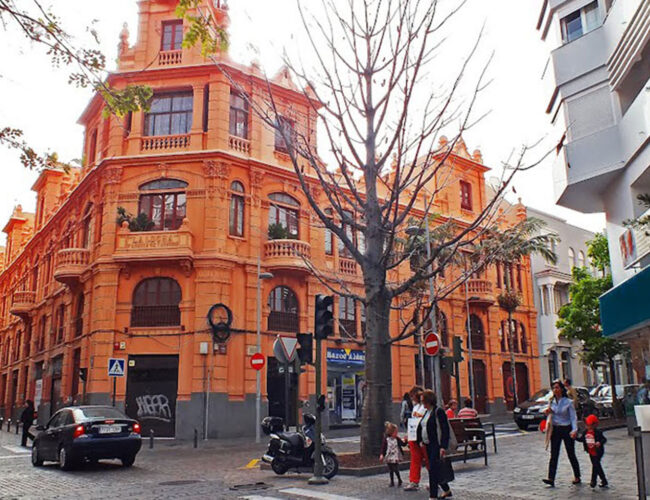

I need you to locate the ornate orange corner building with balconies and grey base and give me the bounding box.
[0,0,540,438]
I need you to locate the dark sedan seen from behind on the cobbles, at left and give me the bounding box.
[32,406,142,470]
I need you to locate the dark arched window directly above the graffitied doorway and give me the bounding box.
[131,278,181,326]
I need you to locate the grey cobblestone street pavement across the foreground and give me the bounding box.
[0,429,636,500]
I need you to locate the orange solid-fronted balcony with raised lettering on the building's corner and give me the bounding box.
[113,219,194,267]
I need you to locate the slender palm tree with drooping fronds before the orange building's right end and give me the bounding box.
[478,217,559,407]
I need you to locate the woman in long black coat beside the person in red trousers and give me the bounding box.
[417,390,454,498]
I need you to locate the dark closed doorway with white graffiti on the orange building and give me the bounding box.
[125,356,178,437]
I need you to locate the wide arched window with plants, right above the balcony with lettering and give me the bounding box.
[138,179,187,231]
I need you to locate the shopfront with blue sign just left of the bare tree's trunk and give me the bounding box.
[327,348,366,424]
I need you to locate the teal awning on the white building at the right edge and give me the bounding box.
[600,267,650,337]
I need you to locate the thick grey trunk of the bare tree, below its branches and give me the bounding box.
[361,287,394,456]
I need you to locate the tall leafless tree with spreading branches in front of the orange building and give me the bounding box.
[186,0,541,455]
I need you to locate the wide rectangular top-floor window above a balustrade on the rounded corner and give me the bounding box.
[144,92,192,136]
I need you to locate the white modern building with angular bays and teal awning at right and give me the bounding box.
[537,0,650,378]
